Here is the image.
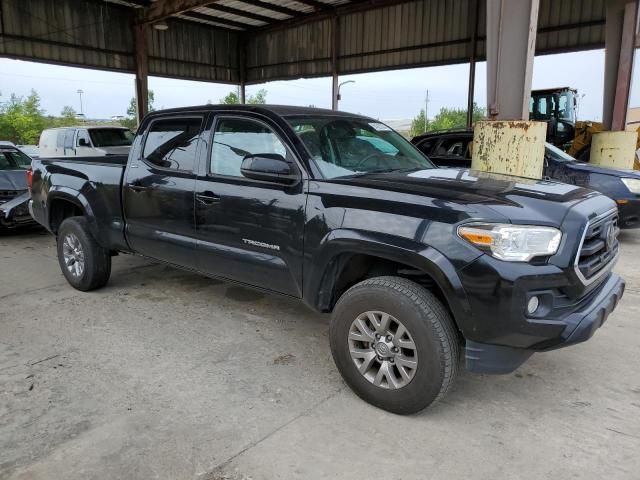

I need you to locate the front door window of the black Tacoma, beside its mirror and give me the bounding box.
[210,118,287,177]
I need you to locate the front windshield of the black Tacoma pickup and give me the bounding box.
[287,115,434,178]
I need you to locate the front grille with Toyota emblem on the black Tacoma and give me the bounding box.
[575,210,620,284]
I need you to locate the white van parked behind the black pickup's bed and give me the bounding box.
[38,126,133,158]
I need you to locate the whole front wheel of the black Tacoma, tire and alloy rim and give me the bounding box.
[330,277,460,414]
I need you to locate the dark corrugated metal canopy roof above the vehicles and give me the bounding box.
[0,0,605,84]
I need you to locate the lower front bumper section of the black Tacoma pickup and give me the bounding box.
[465,273,625,373]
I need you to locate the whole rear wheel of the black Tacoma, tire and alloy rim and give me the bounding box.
[57,217,111,292]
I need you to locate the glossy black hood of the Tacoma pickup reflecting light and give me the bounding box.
[336,168,613,227]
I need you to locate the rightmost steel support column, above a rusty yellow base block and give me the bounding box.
[602,0,638,132]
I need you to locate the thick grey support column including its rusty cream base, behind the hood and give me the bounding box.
[480,0,547,178]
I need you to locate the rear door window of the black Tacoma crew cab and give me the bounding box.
[143,117,202,172]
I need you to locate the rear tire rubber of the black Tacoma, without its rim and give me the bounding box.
[57,217,111,292]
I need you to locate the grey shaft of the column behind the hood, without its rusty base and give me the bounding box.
[487,0,539,120]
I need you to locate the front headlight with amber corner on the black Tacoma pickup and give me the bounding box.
[458,223,562,262]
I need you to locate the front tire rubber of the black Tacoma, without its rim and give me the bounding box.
[329,277,460,415]
